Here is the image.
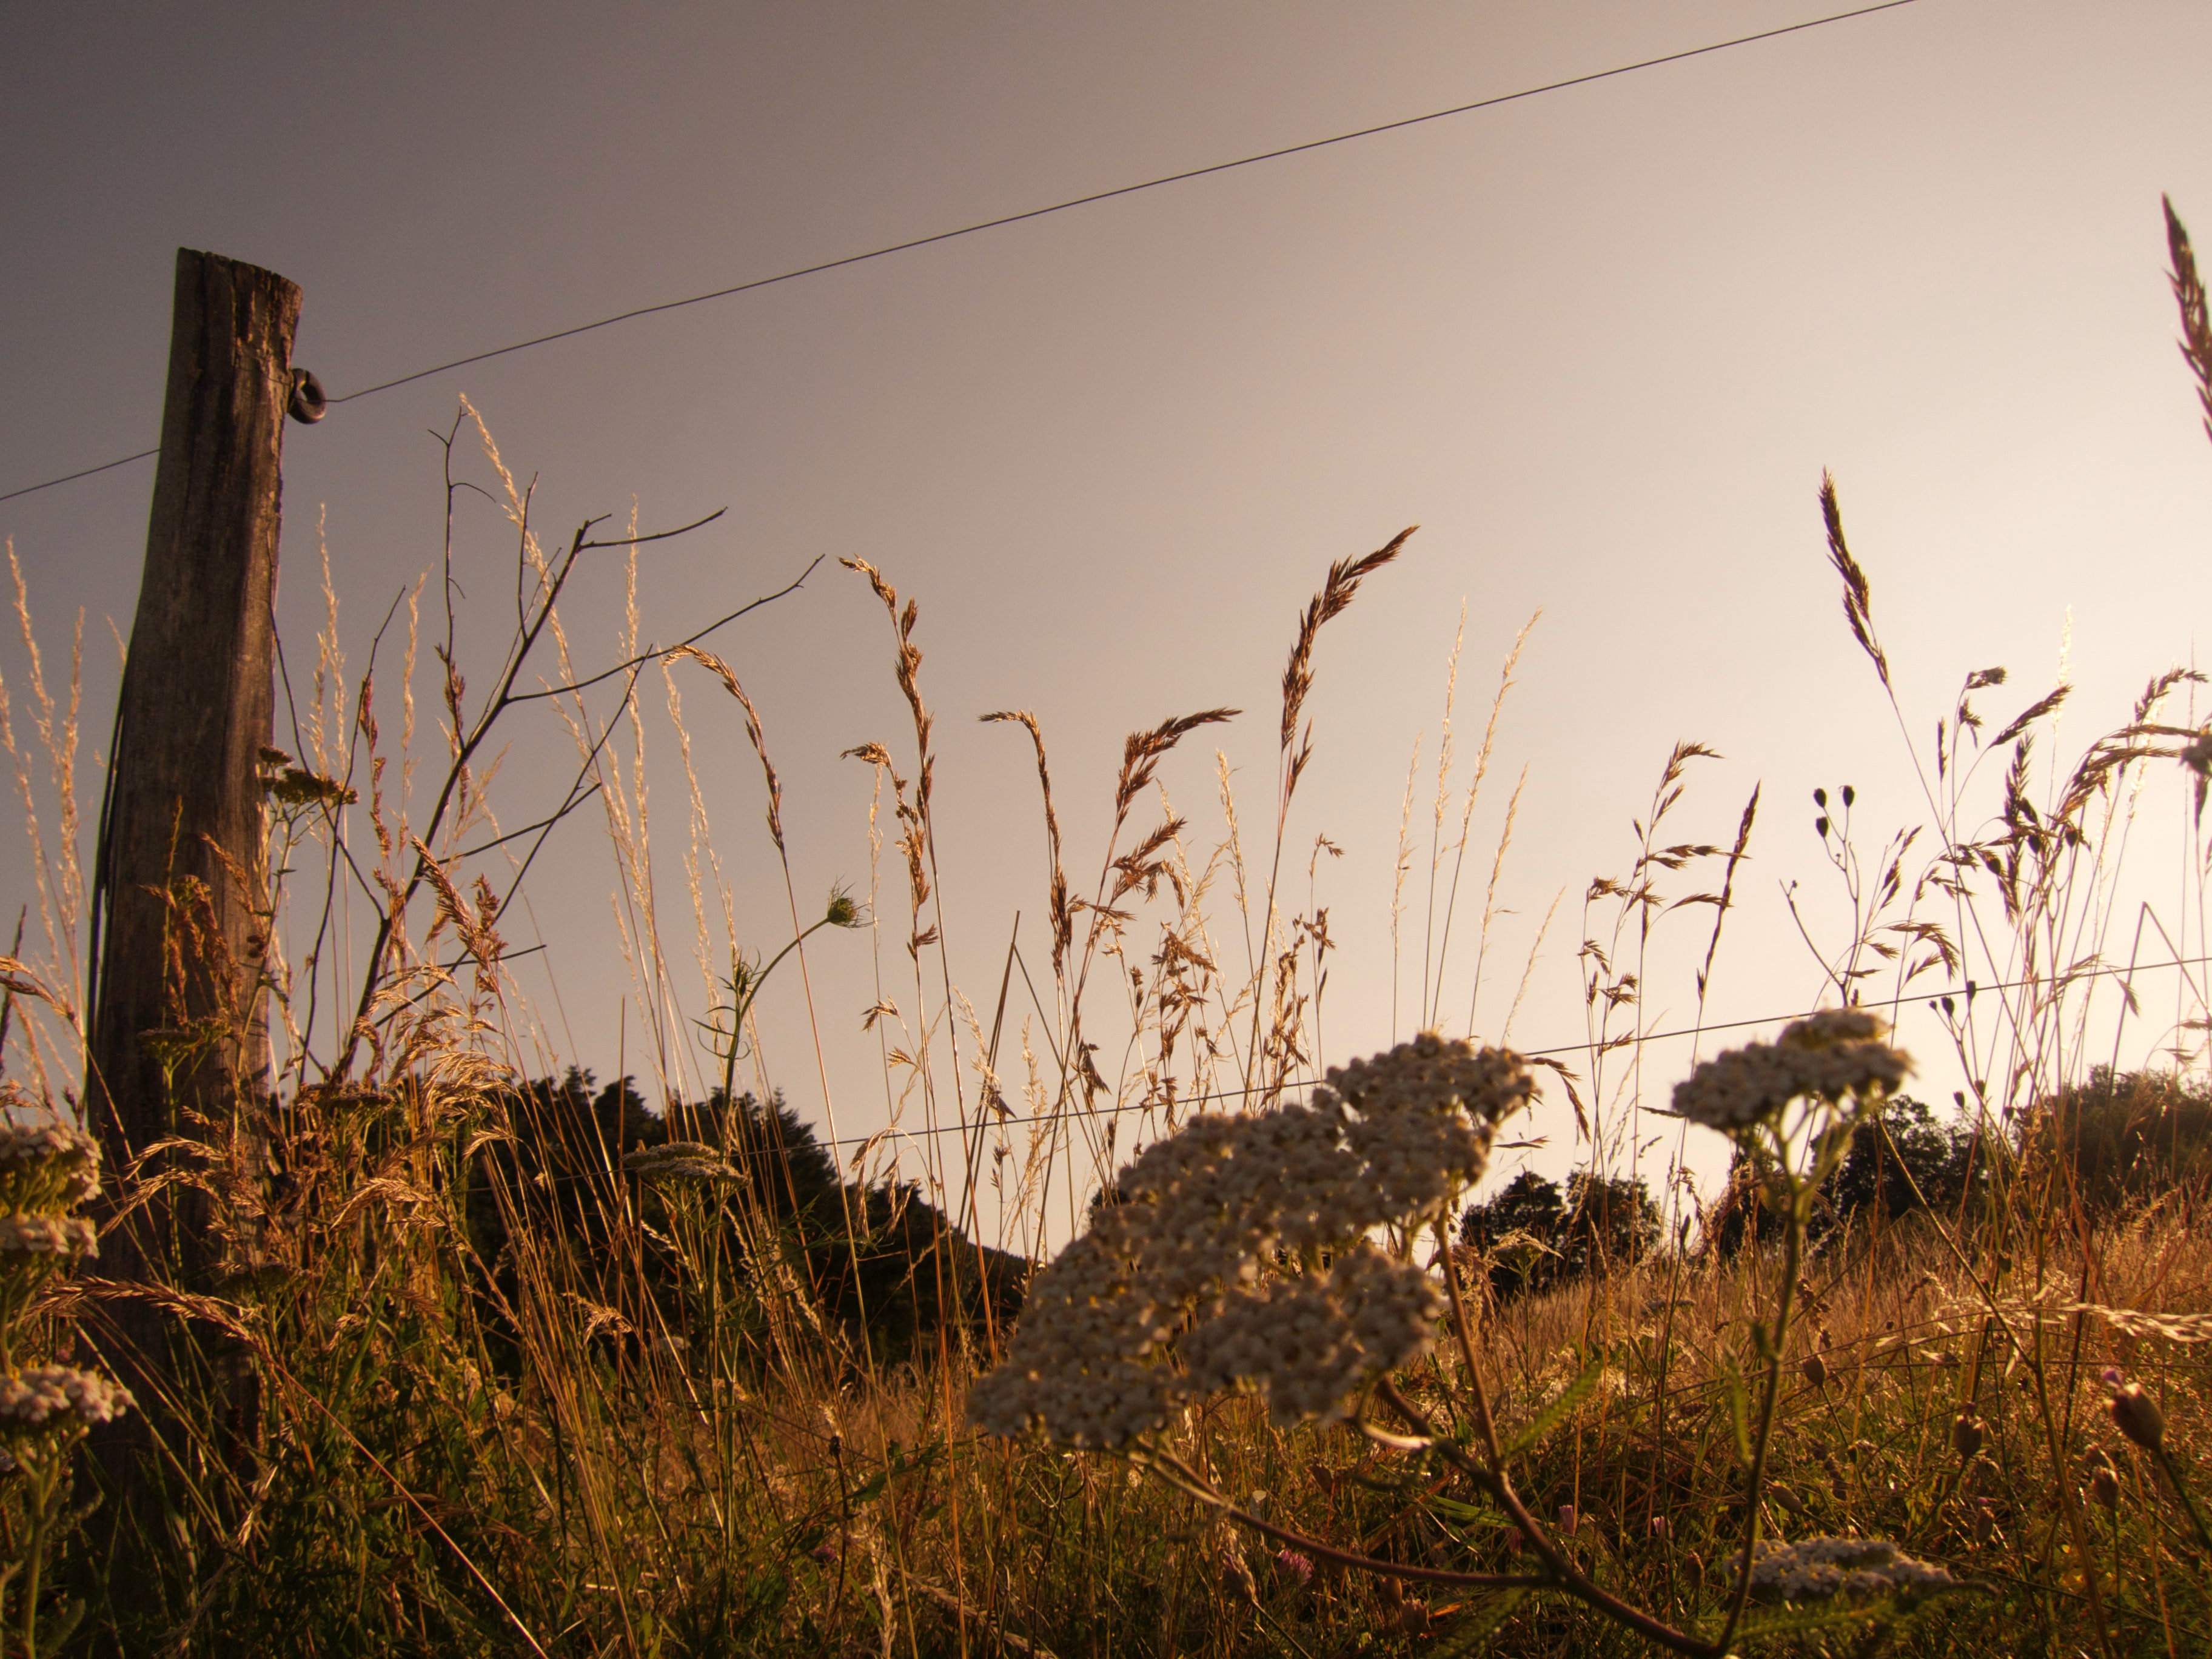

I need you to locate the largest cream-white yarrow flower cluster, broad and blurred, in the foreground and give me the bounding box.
[969,1033,1533,1447]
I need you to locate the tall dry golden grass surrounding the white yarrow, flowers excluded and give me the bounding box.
[0,221,2212,1659]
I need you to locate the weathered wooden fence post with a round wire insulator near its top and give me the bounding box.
[84,248,301,1627]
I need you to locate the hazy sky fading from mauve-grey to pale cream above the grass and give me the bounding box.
[0,0,2212,1247]
